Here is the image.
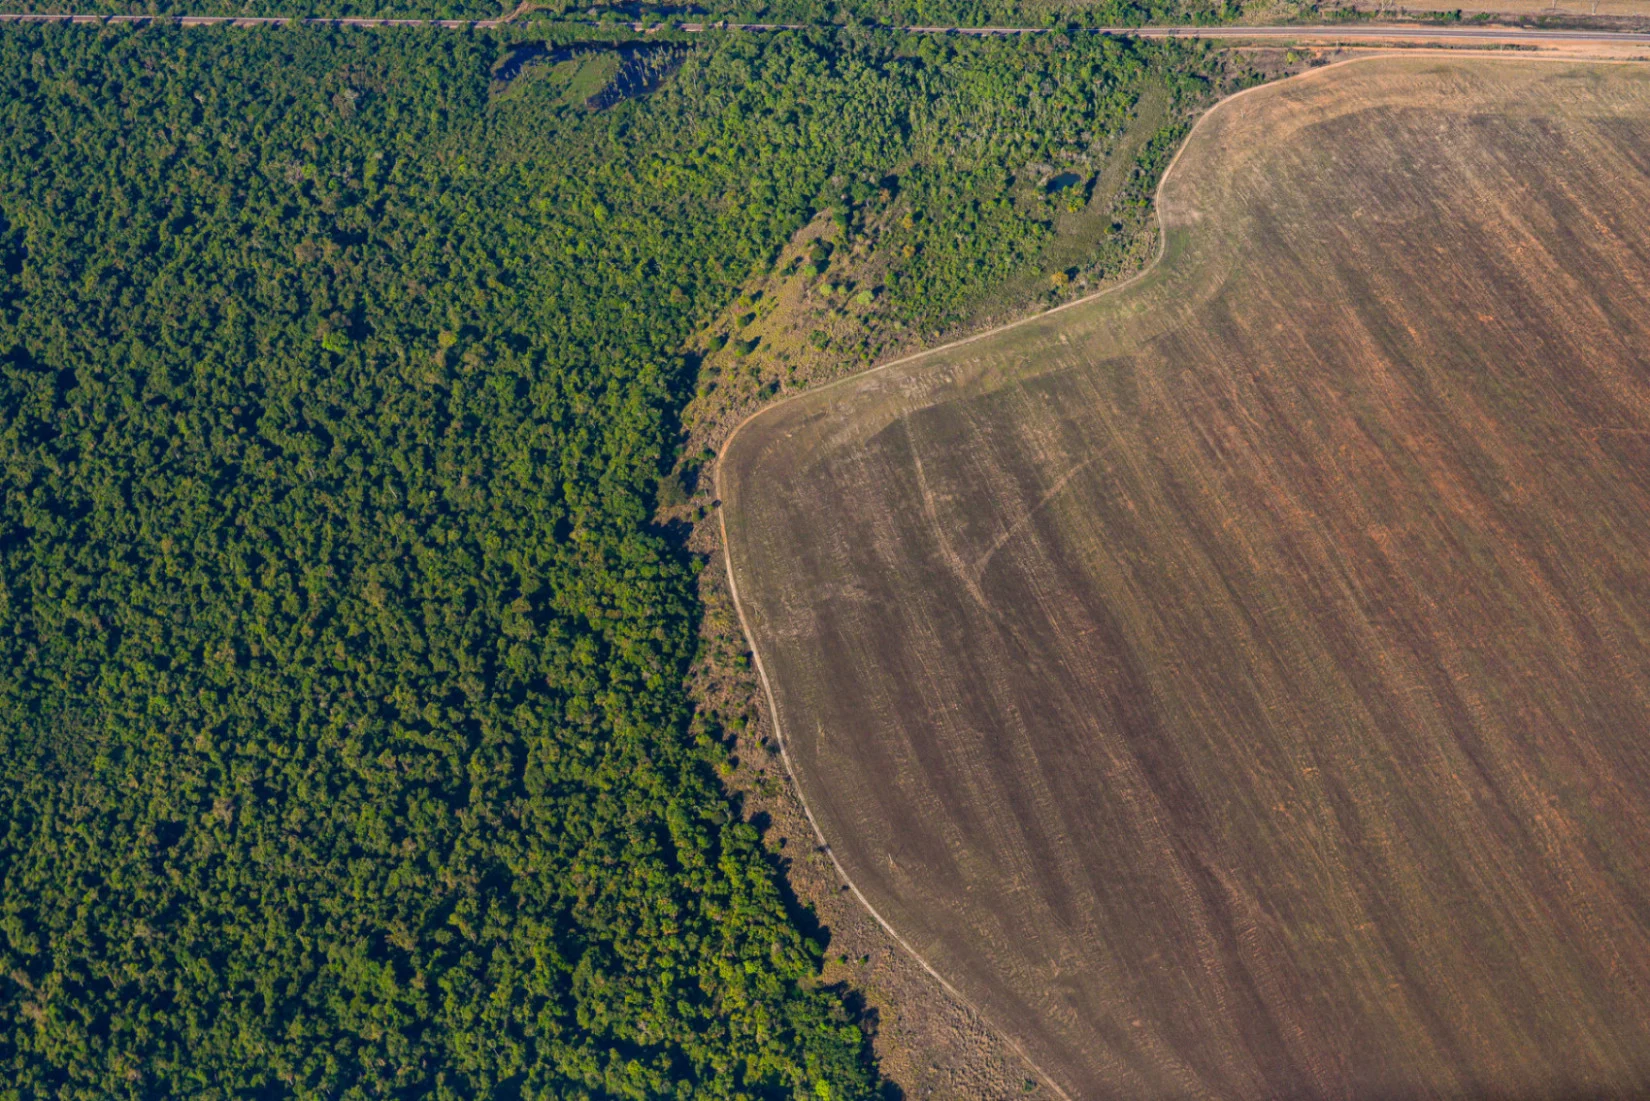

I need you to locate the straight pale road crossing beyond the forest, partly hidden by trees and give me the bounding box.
[0,12,1650,45]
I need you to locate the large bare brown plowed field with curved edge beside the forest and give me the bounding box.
[718,56,1650,1098]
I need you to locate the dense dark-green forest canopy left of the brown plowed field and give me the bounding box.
[0,19,1196,1101]
